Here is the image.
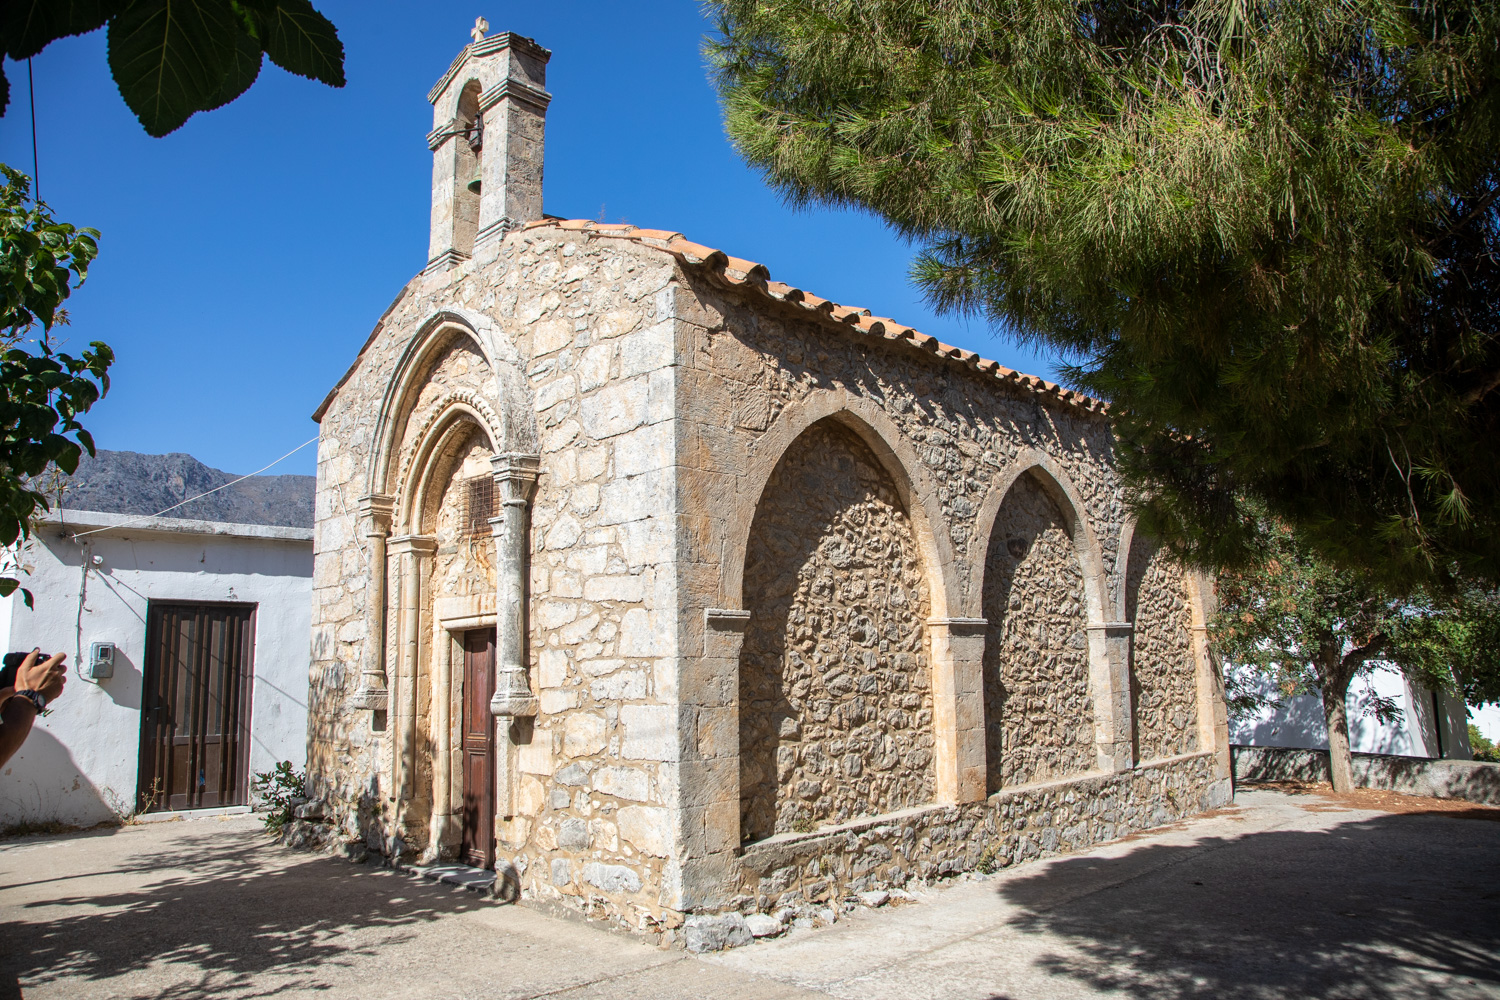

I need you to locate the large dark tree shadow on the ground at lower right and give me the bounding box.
[989,810,1500,1000]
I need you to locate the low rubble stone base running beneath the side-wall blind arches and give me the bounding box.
[735,753,1232,913]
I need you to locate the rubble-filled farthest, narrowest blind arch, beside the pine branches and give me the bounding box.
[1125,535,1199,762]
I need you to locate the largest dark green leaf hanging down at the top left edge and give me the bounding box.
[110,0,243,136]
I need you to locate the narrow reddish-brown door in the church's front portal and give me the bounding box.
[459,628,495,868]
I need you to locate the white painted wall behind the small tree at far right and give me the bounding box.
[1226,666,1470,760]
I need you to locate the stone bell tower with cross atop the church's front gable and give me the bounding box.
[428,18,552,271]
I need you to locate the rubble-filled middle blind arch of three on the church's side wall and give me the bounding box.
[983,468,1098,792]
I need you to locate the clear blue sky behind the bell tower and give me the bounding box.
[0,0,1055,474]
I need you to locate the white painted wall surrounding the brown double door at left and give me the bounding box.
[0,511,312,828]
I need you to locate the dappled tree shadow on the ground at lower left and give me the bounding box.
[0,831,491,1000]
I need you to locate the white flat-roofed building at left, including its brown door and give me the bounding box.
[0,510,312,829]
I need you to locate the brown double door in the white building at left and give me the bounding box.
[137,601,255,811]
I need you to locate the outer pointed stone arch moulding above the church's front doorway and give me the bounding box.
[368,307,540,495]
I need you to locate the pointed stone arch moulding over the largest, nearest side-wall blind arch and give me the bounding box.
[720,390,957,618]
